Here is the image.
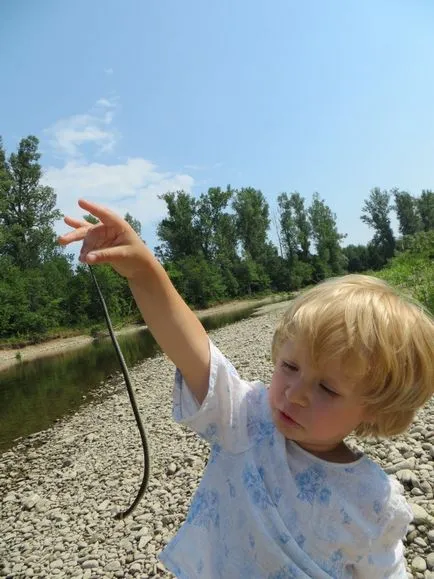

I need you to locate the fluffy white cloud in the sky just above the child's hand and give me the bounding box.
[43,98,194,240]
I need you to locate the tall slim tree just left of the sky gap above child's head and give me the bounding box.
[309,193,345,280]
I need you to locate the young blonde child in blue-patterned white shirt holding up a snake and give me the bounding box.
[60,201,434,579]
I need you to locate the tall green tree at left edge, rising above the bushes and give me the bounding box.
[0,136,62,269]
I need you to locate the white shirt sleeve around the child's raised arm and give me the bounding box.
[173,341,254,453]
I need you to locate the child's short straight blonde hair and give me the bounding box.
[272,275,434,437]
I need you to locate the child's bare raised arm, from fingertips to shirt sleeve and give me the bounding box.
[59,200,210,404]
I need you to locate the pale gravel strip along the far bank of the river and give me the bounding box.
[0,296,288,372]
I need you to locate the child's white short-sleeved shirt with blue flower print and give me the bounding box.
[160,343,412,579]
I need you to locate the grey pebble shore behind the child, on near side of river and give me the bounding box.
[0,311,434,579]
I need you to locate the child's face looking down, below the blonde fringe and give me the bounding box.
[269,340,367,460]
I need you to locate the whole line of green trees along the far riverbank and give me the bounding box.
[0,136,434,342]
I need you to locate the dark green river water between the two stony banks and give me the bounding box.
[0,307,256,451]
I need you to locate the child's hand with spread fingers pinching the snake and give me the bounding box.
[59,199,150,280]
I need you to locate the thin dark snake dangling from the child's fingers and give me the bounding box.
[89,265,151,520]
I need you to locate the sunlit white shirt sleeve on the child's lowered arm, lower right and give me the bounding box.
[355,481,413,579]
